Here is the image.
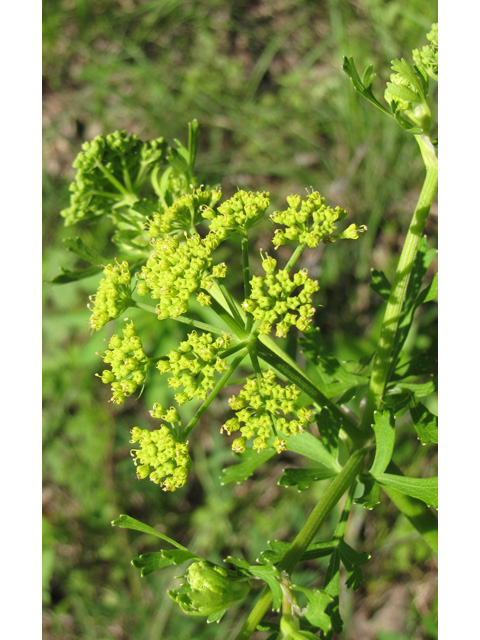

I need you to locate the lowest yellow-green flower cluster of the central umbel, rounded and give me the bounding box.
[130,425,192,491]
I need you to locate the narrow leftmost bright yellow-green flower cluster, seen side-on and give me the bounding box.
[88,261,132,331]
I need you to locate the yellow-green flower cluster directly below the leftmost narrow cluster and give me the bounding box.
[97,320,150,404]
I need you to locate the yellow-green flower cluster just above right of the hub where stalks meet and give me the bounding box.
[242,256,320,338]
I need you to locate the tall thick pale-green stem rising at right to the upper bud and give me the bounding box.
[362,136,438,429]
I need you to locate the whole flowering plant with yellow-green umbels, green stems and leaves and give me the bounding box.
[56,25,438,640]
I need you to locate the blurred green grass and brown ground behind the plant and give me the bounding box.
[43,0,437,640]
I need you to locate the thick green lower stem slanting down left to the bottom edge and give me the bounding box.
[235,449,366,640]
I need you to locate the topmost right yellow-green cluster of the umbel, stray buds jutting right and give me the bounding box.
[270,191,365,249]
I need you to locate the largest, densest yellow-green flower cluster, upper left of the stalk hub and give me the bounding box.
[137,234,224,320]
